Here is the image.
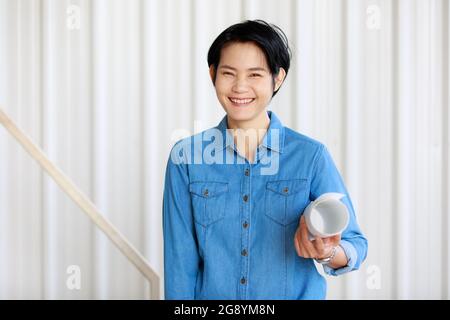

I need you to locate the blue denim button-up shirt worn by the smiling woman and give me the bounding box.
[163,111,367,299]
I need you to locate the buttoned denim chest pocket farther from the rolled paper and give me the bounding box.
[189,182,228,227]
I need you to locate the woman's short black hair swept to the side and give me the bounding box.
[208,19,291,97]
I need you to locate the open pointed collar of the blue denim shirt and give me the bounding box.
[216,111,284,153]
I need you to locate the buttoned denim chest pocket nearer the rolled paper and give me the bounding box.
[265,179,309,226]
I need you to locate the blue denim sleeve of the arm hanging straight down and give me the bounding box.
[162,144,200,300]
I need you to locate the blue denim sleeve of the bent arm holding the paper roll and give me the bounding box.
[310,145,368,276]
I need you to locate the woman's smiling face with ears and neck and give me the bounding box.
[210,42,285,128]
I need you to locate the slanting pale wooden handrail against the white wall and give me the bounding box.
[0,108,160,300]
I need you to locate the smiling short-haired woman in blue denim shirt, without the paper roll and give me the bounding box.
[163,20,367,299]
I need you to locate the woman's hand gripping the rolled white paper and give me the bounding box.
[294,215,341,259]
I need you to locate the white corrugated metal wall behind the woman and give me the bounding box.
[0,0,450,299]
